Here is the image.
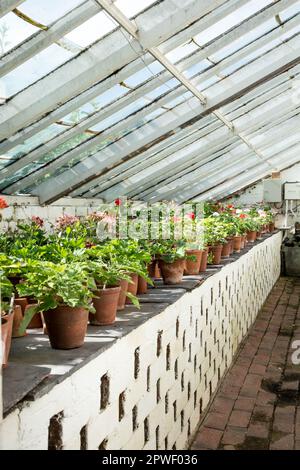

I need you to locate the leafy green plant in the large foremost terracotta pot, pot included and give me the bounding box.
[17,261,96,349]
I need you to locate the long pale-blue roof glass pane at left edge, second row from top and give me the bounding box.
[0,44,73,98]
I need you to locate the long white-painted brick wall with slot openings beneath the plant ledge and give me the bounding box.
[0,234,281,450]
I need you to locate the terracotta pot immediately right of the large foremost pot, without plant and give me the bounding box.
[89,286,121,325]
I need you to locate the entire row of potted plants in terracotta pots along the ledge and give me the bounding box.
[0,199,274,358]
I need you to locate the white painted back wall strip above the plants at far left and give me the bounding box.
[0,195,102,230]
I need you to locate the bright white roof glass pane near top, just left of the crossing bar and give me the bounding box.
[65,11,117,47]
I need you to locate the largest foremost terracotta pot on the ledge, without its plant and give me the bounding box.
[43,305,89,349]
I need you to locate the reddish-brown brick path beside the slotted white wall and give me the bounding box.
[191,278,300,450]
